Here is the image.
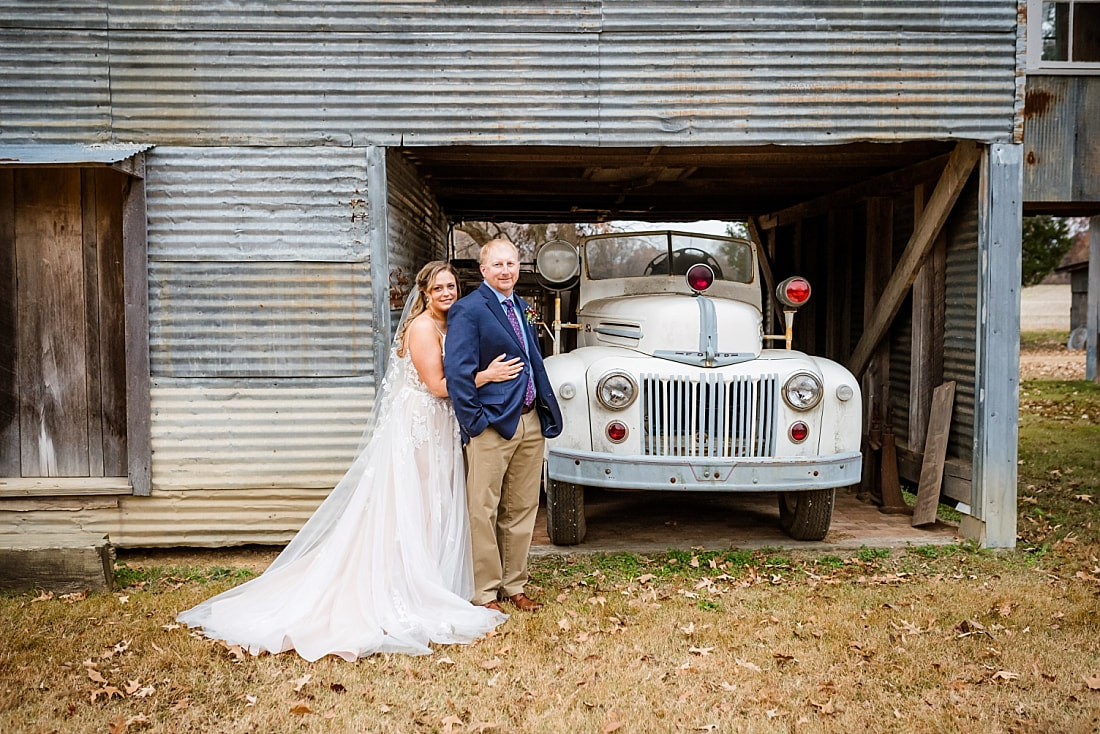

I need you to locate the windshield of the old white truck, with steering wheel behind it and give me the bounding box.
[584,232,752,283]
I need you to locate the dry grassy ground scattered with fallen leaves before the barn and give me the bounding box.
[0,345,1100,733]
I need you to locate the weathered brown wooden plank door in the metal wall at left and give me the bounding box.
[0,167,128,478]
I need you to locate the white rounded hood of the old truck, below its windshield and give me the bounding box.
[578,294,762,366]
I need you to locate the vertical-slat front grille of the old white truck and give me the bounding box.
[641,373,779,459]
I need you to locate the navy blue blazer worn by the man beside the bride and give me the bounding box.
[443,283,562,443]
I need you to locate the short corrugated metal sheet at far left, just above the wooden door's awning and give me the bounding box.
[0,28,110,143]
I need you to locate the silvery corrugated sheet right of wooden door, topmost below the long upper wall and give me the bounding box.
[145,146,367,262]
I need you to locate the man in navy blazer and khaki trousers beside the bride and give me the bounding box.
[443,240,562,612]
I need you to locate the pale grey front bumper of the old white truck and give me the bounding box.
[547,449,864,492]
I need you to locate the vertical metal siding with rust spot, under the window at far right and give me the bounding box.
[1024,76,1100,202]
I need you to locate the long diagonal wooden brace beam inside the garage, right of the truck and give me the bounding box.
[848,141,981,375]
